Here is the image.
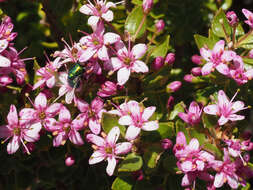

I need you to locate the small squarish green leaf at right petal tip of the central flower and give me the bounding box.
[157,122,175,139]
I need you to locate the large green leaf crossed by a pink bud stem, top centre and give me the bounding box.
[125,6,147,38]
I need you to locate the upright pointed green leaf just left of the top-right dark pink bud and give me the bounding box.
[212,9,231,37]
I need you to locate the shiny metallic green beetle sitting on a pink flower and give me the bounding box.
[68,63,85,88]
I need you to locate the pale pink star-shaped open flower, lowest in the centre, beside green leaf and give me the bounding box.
[87,126,132,176]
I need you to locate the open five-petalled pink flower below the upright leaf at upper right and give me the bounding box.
[200,40,236,75]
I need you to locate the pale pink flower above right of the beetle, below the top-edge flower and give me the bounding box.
[79,22,120,62]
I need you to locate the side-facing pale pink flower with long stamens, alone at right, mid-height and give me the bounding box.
[204,90,248,125]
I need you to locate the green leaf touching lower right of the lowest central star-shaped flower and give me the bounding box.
[118,153,143,172]
